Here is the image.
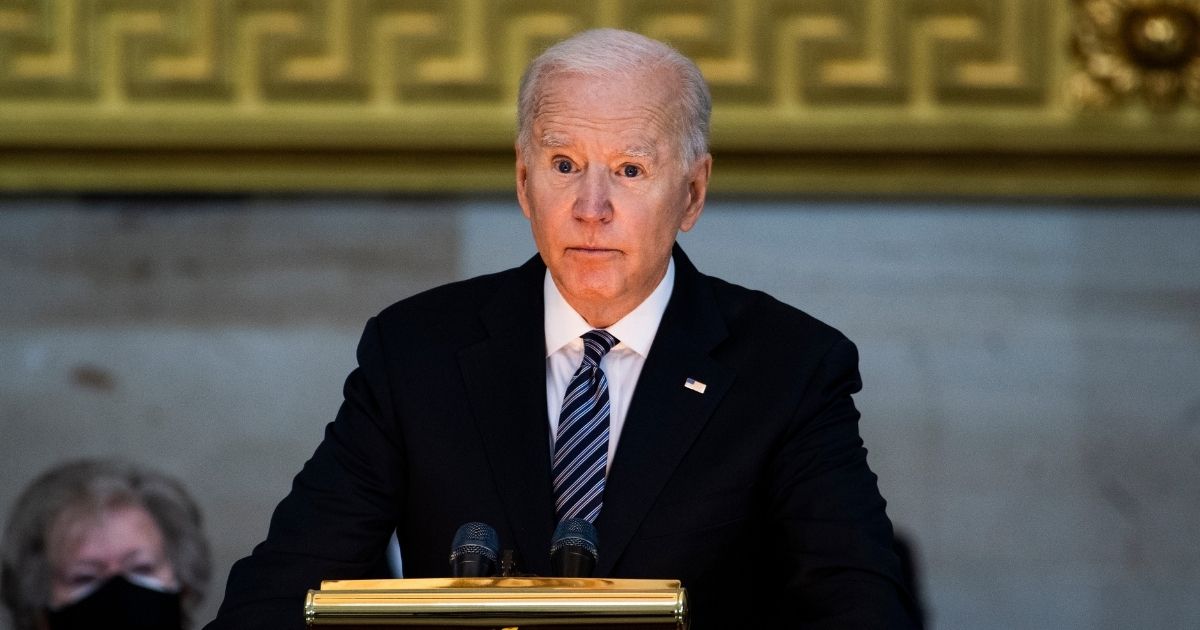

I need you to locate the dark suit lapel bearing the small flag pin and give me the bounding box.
[595,246,734,576]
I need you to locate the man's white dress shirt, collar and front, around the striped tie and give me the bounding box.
[542,259,674,470]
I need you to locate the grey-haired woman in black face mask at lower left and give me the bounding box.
[0,460,211,630]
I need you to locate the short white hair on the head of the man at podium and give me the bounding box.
[517,29,713,168]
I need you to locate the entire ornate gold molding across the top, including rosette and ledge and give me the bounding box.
[0,0,1200,197]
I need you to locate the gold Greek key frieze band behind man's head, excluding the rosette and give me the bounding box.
[0,0,1048,107]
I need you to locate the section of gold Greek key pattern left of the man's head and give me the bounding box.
[0,0,499,103]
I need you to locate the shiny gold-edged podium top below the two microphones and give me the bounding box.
[304,577,688,630]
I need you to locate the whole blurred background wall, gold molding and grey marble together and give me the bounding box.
[0,0,1200,629]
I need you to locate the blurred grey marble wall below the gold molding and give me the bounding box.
[0,196,1200,629]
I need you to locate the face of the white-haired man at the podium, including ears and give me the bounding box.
[517,68,712,328]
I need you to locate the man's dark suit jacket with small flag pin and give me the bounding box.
[209,246,913,630]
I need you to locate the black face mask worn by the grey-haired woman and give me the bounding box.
[46,575,184,630]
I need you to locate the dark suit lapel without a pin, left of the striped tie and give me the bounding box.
[458,256,554,574]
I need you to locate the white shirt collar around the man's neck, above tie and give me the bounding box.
[542,258,674,358]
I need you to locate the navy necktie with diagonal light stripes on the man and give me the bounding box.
[551,330,617,522]
